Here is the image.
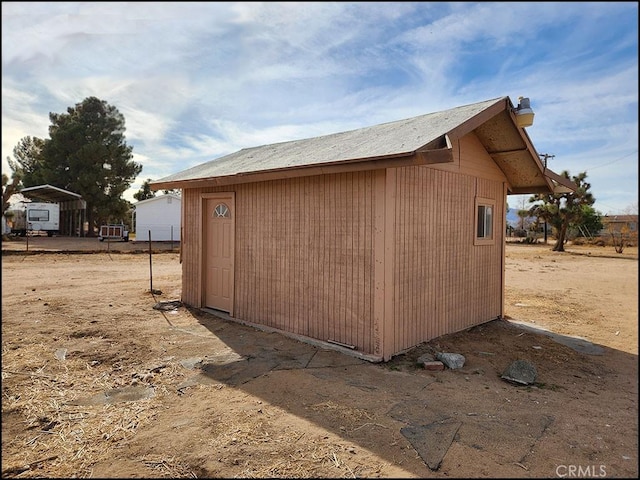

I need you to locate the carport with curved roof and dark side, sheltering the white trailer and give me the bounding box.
[19,184,87,237]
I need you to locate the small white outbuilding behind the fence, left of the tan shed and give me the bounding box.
[133,193,182,242]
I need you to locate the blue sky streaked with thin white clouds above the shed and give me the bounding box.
[2,2,638,214]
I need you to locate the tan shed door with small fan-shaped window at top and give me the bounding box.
[204,195,235,314]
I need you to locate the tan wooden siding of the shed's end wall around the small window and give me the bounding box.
[392,135,506,352]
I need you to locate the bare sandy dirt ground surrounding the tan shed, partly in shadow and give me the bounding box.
[2,237,638,478]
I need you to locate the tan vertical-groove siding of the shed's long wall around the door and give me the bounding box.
[183,171,379,353]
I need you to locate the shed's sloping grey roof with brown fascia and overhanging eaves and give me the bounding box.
[150,97,571,193]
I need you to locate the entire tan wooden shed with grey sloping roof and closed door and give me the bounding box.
[150,97,575,361]
